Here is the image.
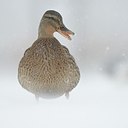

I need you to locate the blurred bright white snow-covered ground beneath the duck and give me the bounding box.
[0,74,128,128]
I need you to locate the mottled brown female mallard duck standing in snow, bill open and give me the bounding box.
[18,10,80,99]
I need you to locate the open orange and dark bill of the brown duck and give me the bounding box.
[57,26,74,40]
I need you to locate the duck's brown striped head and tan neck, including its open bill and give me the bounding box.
[39,10,74,40]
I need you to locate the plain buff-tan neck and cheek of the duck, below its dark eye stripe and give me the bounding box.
[38,21,55,38]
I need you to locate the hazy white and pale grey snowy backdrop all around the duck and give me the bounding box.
[0,0,128,128]
